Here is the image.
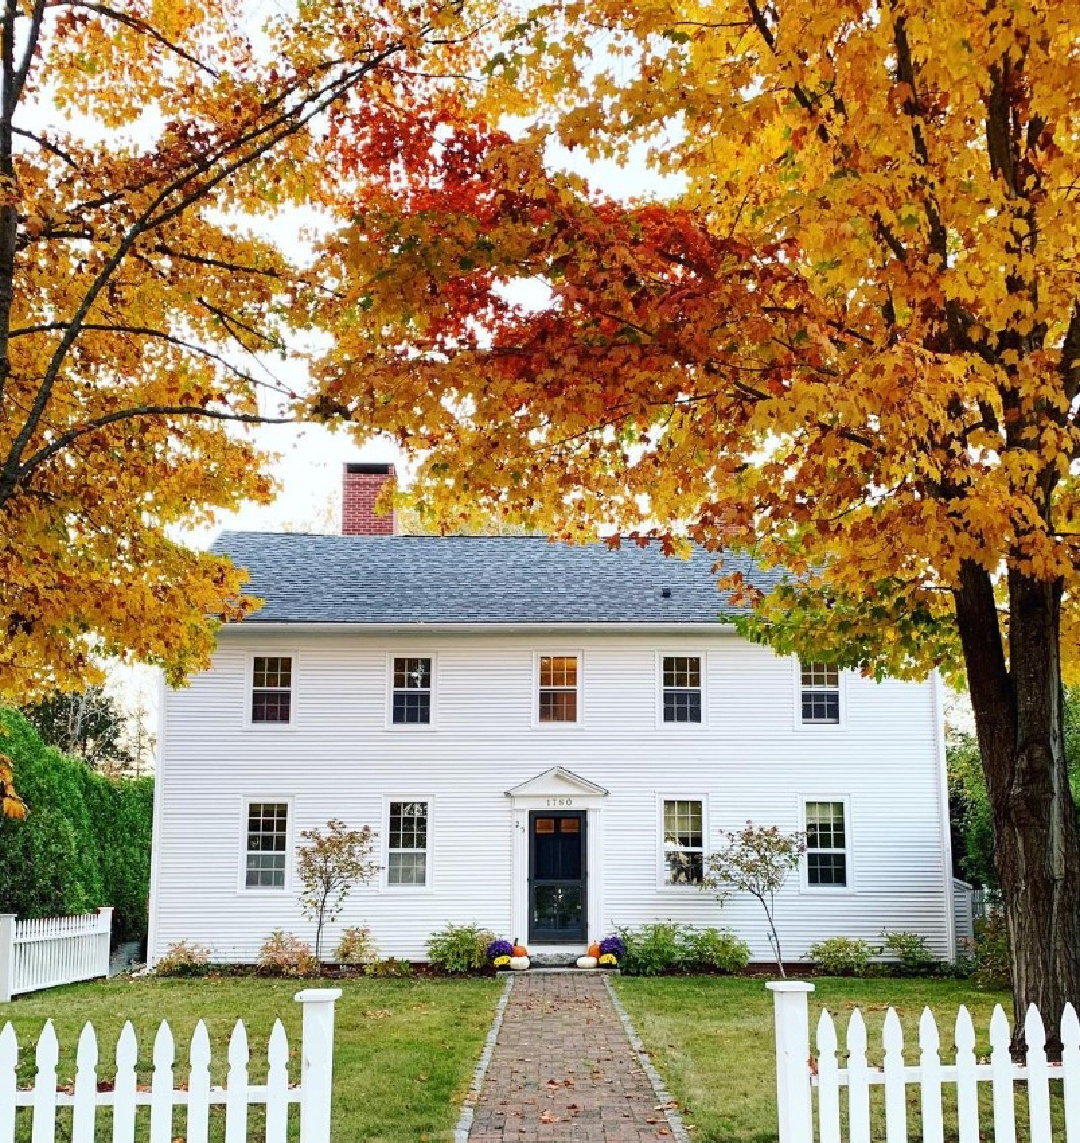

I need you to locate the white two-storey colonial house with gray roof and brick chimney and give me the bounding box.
[150,465,955,961]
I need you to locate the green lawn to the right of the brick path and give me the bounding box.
[615,976,1024,1143]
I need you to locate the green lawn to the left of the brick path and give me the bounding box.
[0,978,502,1143]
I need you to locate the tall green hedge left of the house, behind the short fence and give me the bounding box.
[0,710,153,941]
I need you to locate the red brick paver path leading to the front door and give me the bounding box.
[469,973,672,1143]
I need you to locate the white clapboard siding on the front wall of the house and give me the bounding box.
[151,623,953,961]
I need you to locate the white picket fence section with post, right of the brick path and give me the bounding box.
[768,981,1080,1143]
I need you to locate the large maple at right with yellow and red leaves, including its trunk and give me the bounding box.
[301,0,1080,1034]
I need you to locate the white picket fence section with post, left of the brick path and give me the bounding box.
[0,989,342,1143]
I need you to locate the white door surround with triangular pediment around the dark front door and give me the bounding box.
[506,766,608,952]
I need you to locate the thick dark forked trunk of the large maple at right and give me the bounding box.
[954,563,1080,1057]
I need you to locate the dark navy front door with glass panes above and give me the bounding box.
[529,809,585,944]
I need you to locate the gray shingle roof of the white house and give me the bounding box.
[213,531,783,625]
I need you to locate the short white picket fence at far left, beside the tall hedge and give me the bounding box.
[0,908,112,1002]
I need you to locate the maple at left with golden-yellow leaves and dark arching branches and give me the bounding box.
[0,0,496,731]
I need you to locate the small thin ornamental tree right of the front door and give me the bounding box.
[702,822,806,976]
